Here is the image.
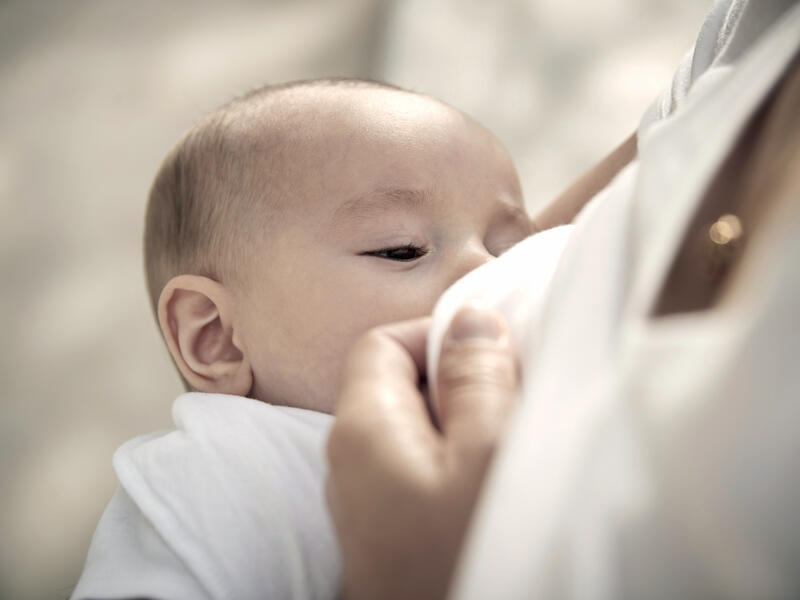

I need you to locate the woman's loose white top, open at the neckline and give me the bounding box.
[449,0,800,600]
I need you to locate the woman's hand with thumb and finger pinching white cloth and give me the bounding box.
[327,307,517,600]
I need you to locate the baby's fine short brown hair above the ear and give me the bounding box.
[144,78,406,319]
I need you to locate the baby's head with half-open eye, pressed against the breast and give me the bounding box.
[145,80,531,412]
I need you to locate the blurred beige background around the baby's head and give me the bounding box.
[0,0,710,599]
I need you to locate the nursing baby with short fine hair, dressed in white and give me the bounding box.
[73,79,532,598]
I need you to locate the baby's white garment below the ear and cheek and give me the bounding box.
[72,393,340,600]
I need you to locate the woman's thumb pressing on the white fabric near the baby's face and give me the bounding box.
[436,305,518,454]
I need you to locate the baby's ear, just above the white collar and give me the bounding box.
[158,275,253,396]
